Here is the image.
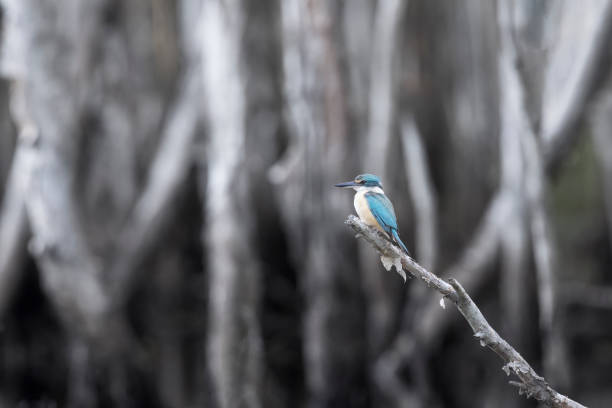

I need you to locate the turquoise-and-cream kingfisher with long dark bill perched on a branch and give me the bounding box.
[335,174,409,254]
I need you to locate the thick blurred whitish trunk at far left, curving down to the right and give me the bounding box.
[5,2,129,406]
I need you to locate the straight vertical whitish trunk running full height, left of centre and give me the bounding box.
[201,0,262,408]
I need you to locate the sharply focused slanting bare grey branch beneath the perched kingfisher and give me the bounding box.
[345,215,584,408]
